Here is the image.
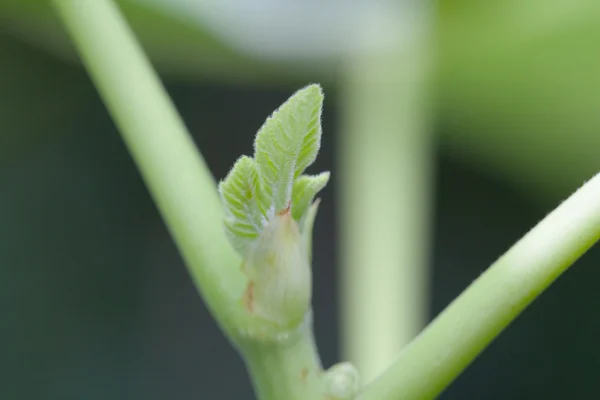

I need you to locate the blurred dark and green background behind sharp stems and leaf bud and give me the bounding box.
[0,0,600,400]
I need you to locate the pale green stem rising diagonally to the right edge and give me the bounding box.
[357,174,600,400]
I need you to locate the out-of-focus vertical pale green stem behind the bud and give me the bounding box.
[339,11,431,383]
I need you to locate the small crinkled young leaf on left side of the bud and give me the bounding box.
[219,156,266,254]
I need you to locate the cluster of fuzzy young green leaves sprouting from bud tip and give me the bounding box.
[219,84,329,257]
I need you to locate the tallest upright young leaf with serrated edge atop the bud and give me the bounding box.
[254,85,323,219]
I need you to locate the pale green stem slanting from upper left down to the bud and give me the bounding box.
[54,0,244,336]
